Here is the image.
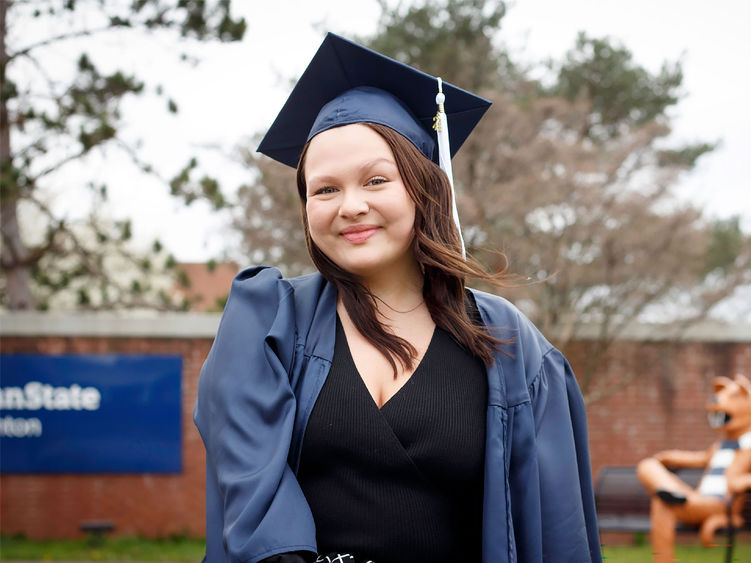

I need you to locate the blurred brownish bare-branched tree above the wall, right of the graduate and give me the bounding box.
[454,85,751,400]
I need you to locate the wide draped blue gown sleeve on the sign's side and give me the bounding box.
[194,269,316,563]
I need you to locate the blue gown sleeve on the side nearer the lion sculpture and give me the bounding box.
[530,348,602,562]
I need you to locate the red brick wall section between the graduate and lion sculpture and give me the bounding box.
[570,342,751,475]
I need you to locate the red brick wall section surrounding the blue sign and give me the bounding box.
[0,337,211,539]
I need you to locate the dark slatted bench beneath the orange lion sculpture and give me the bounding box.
[595,466,751,561]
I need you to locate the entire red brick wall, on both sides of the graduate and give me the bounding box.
[0,337,751,538]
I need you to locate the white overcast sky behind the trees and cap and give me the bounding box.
[26,0,751,261]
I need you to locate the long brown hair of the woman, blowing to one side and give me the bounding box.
[297,123,506,376]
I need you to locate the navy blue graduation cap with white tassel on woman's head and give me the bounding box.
[258,33,490,256]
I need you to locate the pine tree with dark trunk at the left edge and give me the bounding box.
[0,0,246,309]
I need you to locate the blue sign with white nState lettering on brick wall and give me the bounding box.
[0,355,182,473]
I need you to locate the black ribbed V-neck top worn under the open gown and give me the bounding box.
[298,318,487,563]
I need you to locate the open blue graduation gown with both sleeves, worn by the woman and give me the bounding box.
[194,267,601,563]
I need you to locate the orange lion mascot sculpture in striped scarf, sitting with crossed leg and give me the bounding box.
[637,375,751,563]
